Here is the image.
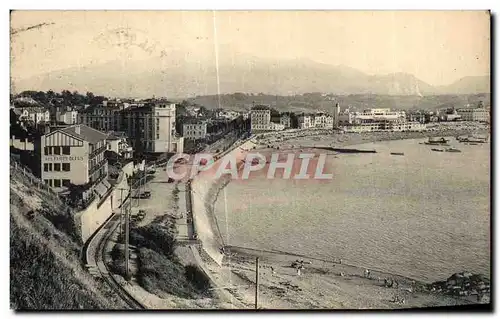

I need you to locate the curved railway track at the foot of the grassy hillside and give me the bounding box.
[84,213,147,310]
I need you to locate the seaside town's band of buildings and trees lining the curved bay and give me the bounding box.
[10,91,490,209]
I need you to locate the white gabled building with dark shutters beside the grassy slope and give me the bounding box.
[36,125,108,191]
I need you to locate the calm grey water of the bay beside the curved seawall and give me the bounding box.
[215,139,490,281]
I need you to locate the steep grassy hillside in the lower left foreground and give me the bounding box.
[10,166,126,310]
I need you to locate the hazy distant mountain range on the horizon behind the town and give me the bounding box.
[13,55,490,97]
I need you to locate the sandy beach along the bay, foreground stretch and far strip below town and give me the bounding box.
[190,125,487,309]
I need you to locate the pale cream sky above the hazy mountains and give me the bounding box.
[11,11,490,85]
